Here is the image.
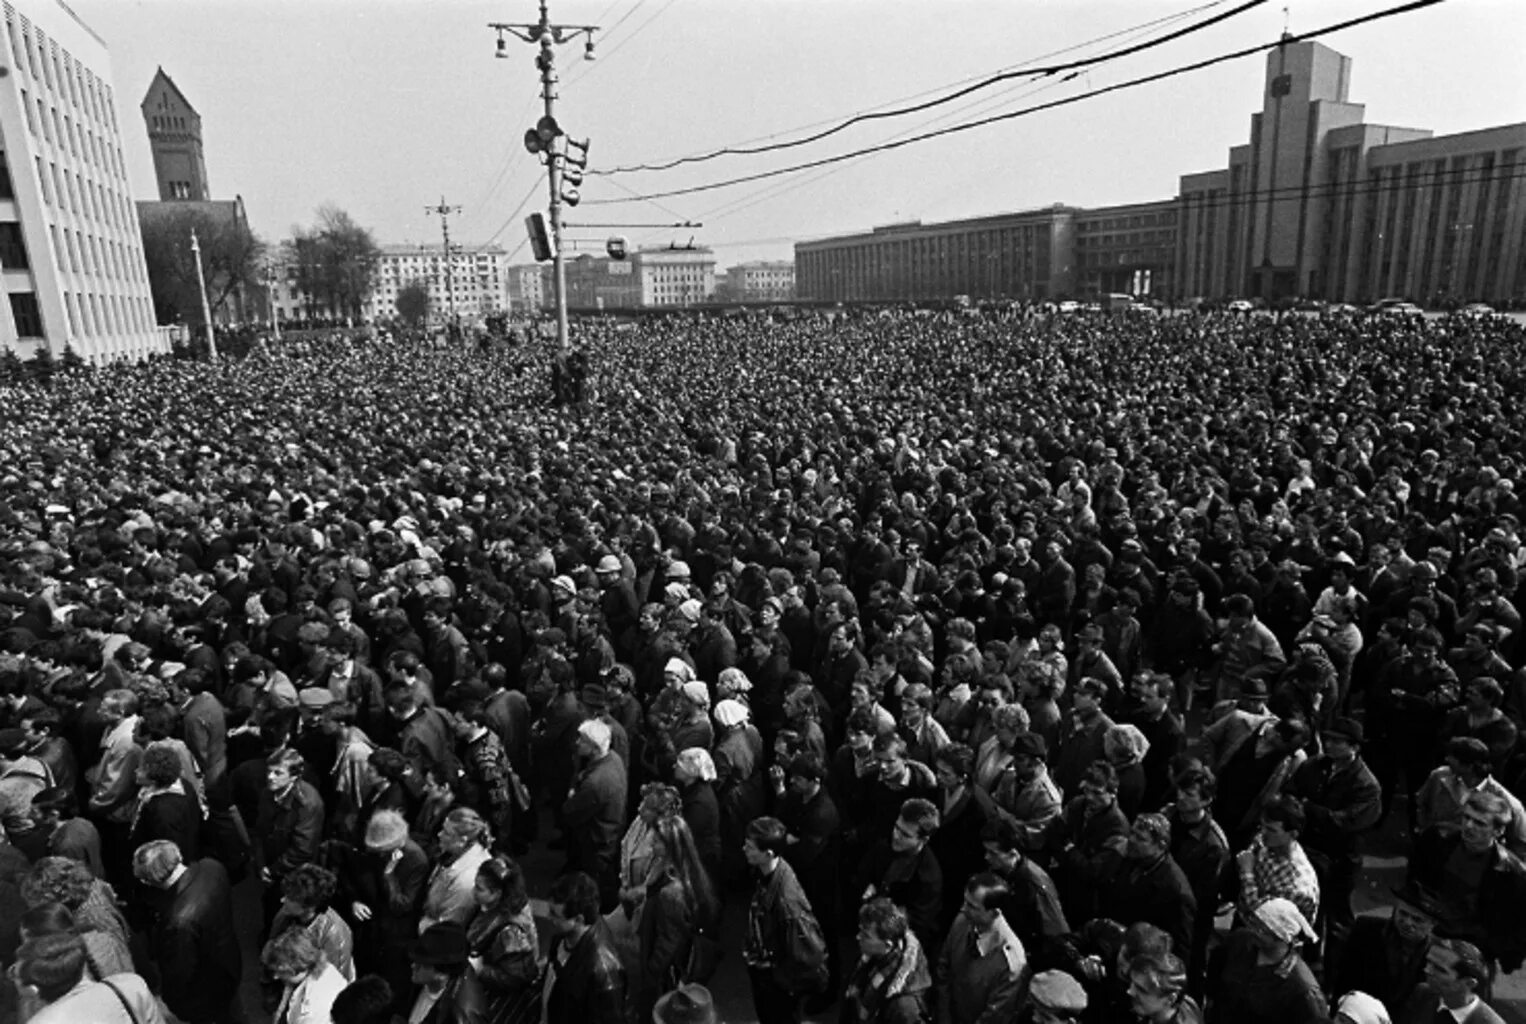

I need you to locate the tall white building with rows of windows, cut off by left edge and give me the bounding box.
[0,0,169,362]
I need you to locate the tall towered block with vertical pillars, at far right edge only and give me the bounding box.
[1178,43,1526,304]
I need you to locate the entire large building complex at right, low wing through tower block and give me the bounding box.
[795,43,1526,305]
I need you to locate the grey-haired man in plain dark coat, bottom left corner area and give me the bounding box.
[133,839,244,1024]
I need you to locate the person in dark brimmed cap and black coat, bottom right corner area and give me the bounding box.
[1326,882,1439,1007]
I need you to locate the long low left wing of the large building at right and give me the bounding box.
[795,204,1082,302]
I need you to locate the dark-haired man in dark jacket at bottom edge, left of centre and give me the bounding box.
[546,871,627,1024]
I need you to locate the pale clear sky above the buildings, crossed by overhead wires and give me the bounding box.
[70,0,1526,266]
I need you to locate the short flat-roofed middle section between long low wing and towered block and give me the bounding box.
[1074,200,1180,298]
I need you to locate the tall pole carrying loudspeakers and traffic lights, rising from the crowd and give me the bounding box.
[488,0,598,356]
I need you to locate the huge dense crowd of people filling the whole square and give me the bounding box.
[0,311,1526,1024]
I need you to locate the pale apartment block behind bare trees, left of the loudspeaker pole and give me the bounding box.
[366,243,510,322]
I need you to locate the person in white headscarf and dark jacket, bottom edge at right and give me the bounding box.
[1206,897,1328,1024]
